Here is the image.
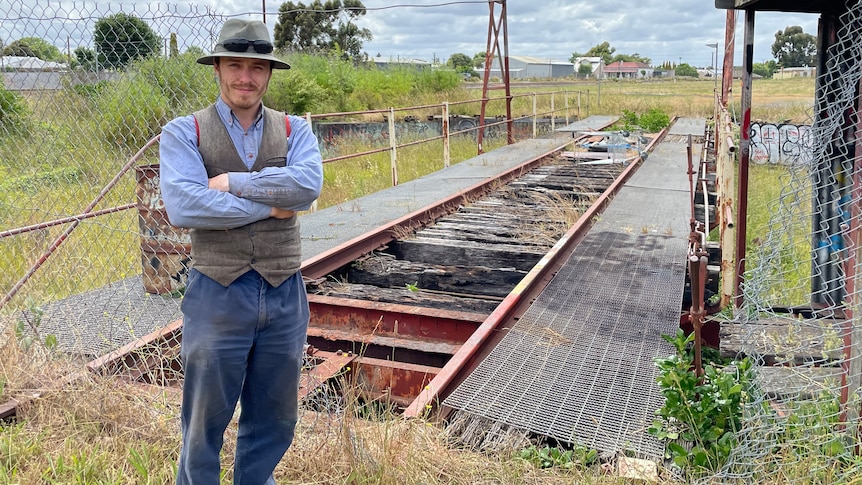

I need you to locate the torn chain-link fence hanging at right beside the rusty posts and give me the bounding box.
[719,2,862,483]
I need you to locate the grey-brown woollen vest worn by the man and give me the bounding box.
[191,105,302,287]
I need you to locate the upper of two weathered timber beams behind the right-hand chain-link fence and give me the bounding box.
[719,317,843,365]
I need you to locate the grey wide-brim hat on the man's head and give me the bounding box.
[198,19,290,69]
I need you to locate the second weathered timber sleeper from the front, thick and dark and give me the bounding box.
[347,253,526,298]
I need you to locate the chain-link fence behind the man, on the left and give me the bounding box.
[0,0,231,355]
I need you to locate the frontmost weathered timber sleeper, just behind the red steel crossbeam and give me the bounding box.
[308,281,500,315]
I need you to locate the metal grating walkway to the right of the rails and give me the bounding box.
[444,120,704,460]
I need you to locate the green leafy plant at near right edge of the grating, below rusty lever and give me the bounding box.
[648,330,752,474]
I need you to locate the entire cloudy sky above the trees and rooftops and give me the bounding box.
[0,0,818,67]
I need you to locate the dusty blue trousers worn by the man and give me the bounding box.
[177,269,309,485]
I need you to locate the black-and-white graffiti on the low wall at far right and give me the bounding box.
[750,122,813,165]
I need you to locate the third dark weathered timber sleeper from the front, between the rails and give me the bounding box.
[389,237,545,271]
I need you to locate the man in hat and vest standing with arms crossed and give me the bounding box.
[160,19,323,485]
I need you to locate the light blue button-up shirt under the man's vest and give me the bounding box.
[159,97,323,229]
